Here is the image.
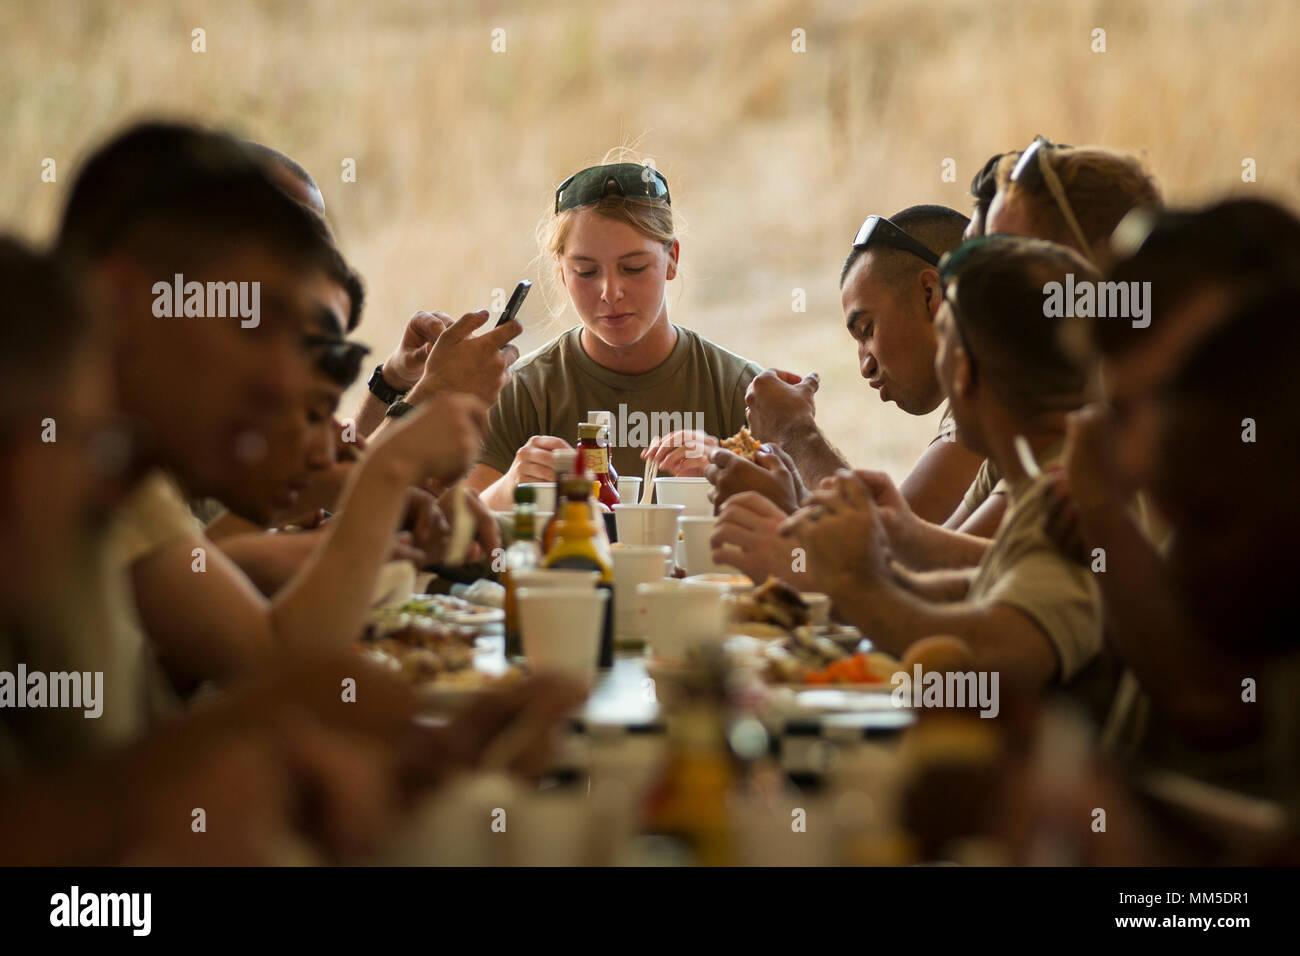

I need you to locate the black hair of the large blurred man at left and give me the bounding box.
[59,122,332,283]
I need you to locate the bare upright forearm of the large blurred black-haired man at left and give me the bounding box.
[272,453,415,649]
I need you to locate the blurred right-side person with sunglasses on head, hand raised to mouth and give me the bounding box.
[1047,199,1300,753]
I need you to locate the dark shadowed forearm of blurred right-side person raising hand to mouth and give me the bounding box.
[1079,507,1245,741]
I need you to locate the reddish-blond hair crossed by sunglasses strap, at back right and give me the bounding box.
[996,146,1161,255]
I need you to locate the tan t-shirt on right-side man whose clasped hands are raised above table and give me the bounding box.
[967,463,1101,683]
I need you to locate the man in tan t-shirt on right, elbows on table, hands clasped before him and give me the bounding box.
[788,237,1101,691]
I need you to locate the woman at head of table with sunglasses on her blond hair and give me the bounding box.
[468,163,761,510]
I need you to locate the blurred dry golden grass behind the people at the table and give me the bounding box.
[0,0,1300,477]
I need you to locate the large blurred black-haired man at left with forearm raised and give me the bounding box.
[60,124,484,689]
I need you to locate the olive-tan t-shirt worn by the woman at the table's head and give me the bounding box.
[478,325,762,476]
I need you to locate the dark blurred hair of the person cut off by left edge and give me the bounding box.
[0,238,91,414]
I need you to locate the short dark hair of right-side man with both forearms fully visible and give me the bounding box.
[949,235,1100,415]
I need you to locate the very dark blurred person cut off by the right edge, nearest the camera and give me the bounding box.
[1143,293,1300,827]
